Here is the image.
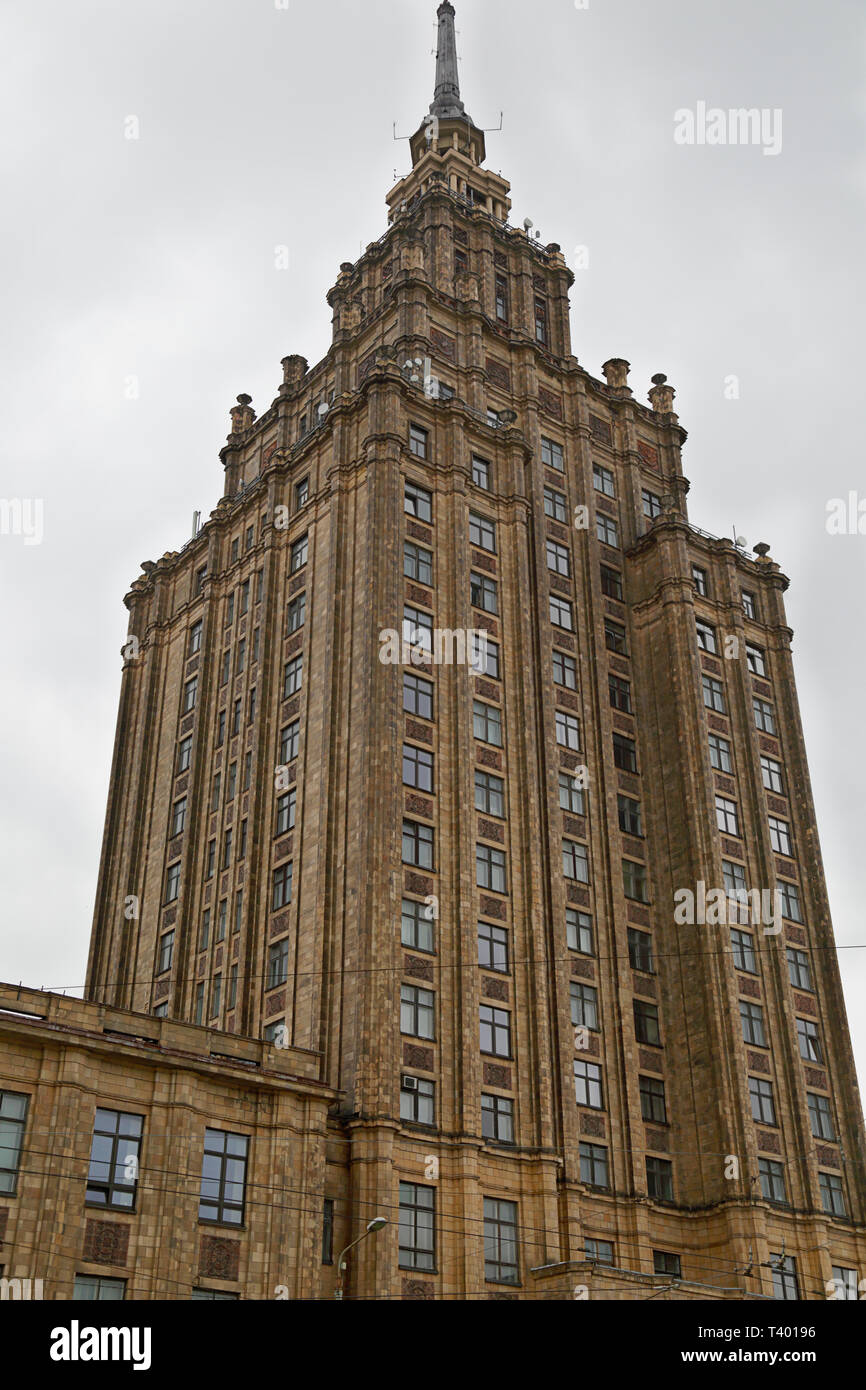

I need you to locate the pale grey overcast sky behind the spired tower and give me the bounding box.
[0,0,866,1083]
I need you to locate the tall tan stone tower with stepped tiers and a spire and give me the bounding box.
[88,3,866,1298]
